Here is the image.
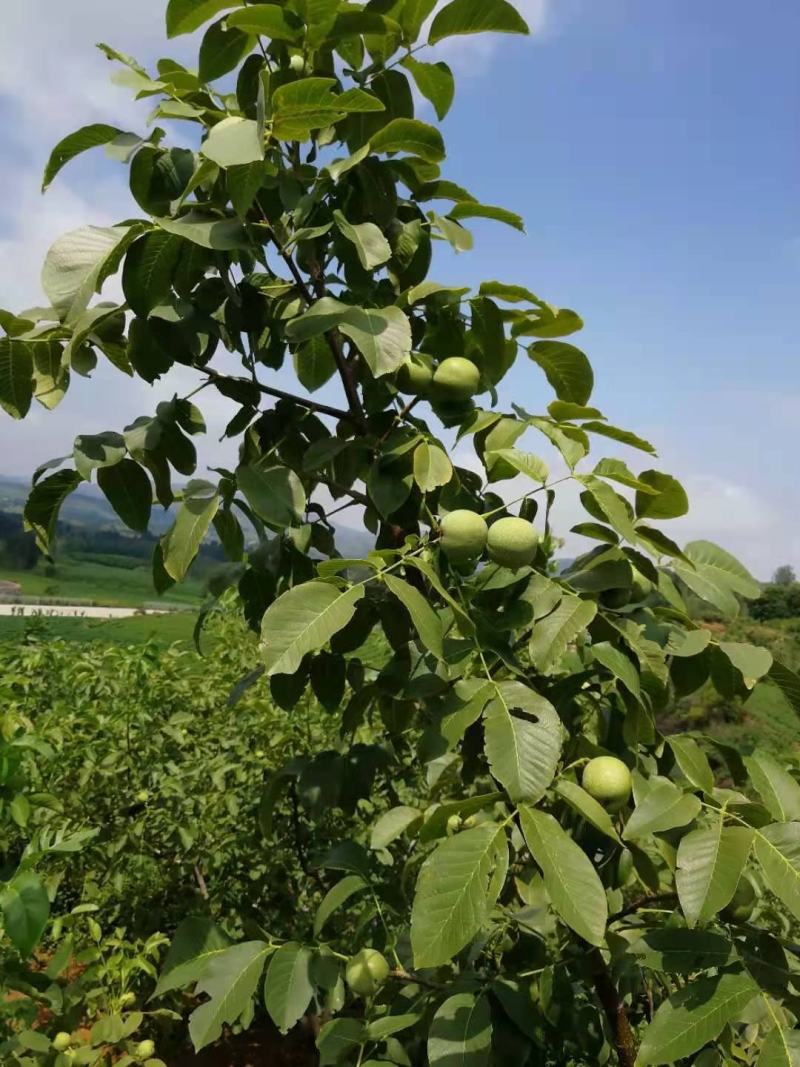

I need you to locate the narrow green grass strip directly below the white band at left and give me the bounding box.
[0,611,196,646]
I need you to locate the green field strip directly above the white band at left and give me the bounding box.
[0,556,203,607]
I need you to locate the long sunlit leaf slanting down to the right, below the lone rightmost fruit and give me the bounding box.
[519,808,608,945]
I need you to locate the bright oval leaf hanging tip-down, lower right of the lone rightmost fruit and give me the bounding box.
[675,814,753,926]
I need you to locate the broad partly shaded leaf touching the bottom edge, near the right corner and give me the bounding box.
[637,973,758,1065]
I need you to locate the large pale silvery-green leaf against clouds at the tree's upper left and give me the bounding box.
[42,226,143,322]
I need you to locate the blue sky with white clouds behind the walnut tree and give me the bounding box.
[0,0,800,577]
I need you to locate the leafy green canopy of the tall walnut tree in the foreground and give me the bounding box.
[0,0,800,1067]
